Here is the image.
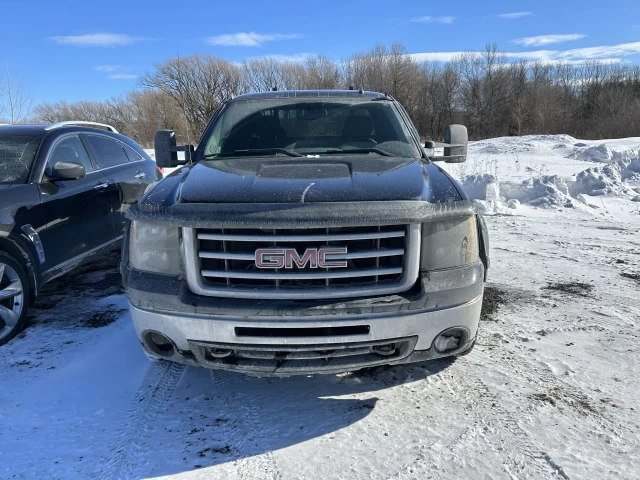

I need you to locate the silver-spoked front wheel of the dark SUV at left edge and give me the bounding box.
[0,252,29,345]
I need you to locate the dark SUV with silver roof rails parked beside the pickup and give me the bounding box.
[0,122,161,345]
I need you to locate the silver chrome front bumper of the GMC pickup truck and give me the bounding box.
[131,294,482,376]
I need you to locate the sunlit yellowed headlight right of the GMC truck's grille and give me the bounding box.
[420,217,478,271]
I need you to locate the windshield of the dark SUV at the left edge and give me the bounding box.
[0,135,40,184]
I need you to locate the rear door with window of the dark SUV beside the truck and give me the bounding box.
[83,133,154,235]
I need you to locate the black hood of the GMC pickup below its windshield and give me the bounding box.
[170,155,462,205]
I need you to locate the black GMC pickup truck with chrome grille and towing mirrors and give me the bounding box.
[122,90,489,375]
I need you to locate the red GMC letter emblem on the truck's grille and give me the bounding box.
[256,247,347,268]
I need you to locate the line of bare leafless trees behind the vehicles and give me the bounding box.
[26,44,640,147]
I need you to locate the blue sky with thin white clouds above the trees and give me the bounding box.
[0,0,640,103]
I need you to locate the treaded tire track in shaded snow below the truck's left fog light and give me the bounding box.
[100,360,186,480]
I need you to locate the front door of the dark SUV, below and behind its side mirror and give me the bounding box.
[40,135,116,270]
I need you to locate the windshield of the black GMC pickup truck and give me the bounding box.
[201,99,420,158]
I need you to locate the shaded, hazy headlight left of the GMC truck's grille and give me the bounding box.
[129,222,180,275]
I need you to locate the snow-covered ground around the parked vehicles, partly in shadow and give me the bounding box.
[0,136,640,480]
